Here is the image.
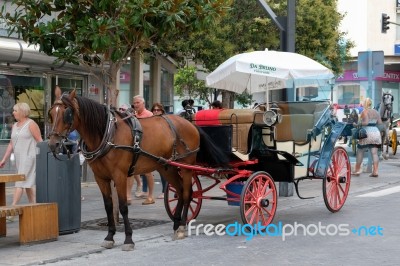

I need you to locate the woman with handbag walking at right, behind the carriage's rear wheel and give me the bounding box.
[352,98,382,177]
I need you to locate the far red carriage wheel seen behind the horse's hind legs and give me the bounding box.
[164,175,203,222]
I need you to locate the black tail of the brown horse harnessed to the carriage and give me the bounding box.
[196,126,229,167]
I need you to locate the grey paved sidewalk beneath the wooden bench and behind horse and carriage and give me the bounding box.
[0,145,400,265]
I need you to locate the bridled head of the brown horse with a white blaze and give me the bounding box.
[48,90,79,154]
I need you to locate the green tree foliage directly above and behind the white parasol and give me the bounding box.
[159,0,353,106]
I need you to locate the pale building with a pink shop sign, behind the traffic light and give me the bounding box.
[333,0,400,116]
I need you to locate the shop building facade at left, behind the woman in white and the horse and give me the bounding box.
[0,3,176,175]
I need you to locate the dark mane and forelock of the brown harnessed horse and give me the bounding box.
[61,96,107,137]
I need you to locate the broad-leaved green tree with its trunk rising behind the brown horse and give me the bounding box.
[0,0,231,105]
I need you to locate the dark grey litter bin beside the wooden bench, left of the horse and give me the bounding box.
[36,141,81,235]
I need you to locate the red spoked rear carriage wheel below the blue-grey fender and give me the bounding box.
[322,147,351,212]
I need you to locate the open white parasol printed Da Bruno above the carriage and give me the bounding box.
[206,50,334,102]
